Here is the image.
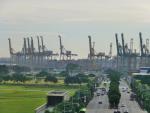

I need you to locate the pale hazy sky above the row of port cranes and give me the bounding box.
[0,0,150,58]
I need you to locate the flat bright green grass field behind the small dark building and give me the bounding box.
[0,85,78,113]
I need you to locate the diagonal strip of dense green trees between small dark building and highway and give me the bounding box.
[49,81,95,113]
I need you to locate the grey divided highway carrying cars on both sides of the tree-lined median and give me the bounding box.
[87,80,147,113]
